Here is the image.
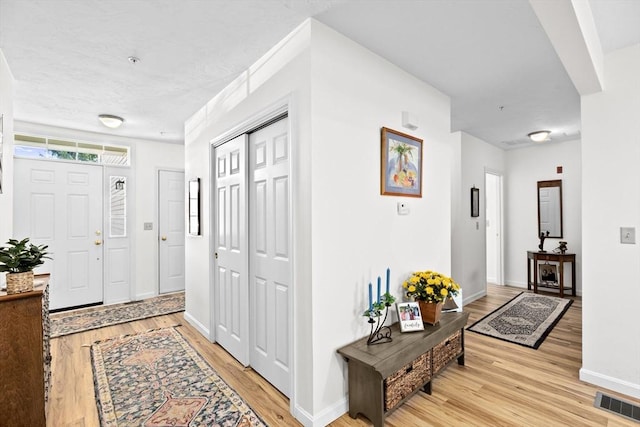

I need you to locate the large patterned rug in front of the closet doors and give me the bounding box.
[91,328,266,427]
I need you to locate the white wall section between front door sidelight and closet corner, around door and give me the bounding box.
[132,140,188,299]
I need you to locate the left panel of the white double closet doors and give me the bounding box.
[213,135,249,366]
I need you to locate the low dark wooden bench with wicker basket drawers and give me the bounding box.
[338,312,469,427]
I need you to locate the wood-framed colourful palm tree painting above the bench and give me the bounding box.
[380,127,422,197]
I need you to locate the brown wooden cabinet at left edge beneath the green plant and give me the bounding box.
[0,276,51,427]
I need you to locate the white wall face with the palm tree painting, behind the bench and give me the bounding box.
[310,22,455,420]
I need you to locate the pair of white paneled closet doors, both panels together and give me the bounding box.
[213,118,291,396]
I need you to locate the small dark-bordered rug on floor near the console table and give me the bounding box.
[467,292,573,349]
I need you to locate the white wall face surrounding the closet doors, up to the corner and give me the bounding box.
[185,17,313,418]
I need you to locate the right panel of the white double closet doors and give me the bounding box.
[249,118,291,396]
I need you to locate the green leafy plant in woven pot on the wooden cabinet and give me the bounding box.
[0,238,51,294]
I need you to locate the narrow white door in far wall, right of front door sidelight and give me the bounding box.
[158,170,186,294]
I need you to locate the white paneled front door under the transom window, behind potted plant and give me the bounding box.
[14,159,103,310]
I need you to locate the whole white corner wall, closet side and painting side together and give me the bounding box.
[186,20,453,425]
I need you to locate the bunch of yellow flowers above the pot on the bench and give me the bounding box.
[402,270,460,303]
